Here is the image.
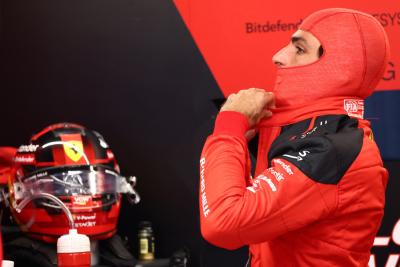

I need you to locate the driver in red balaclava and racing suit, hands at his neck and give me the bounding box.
[200,8,389,267]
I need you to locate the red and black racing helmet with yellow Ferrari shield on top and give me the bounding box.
[9,123,125,242]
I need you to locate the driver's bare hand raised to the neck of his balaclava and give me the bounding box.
[221,88,275,128]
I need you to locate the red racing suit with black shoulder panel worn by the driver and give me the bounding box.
[200,100,388,267]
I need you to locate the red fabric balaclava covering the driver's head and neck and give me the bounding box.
[274,8,389,117]
